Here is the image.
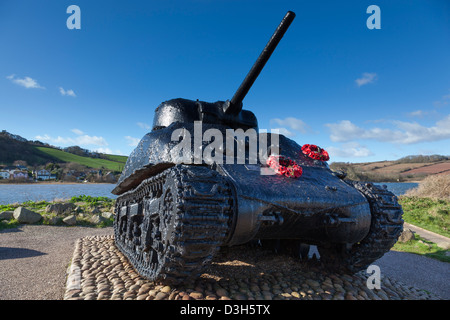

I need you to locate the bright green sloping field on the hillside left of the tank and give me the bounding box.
[36,147,127,171]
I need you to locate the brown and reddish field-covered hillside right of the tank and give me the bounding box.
[330,155,450,182]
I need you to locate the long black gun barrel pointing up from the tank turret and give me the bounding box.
[226,11,295,114]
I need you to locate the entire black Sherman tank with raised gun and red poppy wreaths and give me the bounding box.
[112,11,403,283]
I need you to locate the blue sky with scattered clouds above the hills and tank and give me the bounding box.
[0,0,450,162]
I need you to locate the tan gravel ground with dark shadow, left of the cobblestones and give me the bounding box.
[0,225,113,300]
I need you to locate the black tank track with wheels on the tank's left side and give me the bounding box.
[114,165,234,283]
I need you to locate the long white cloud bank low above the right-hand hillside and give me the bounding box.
[326,114,450,144]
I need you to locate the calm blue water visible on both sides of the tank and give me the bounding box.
[0,183,418,204]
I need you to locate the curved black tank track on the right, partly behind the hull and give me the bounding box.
[318,181,403,273]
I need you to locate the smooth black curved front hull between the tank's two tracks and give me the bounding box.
[219,165,371,245]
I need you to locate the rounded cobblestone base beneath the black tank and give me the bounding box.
[64,235,440,300]
